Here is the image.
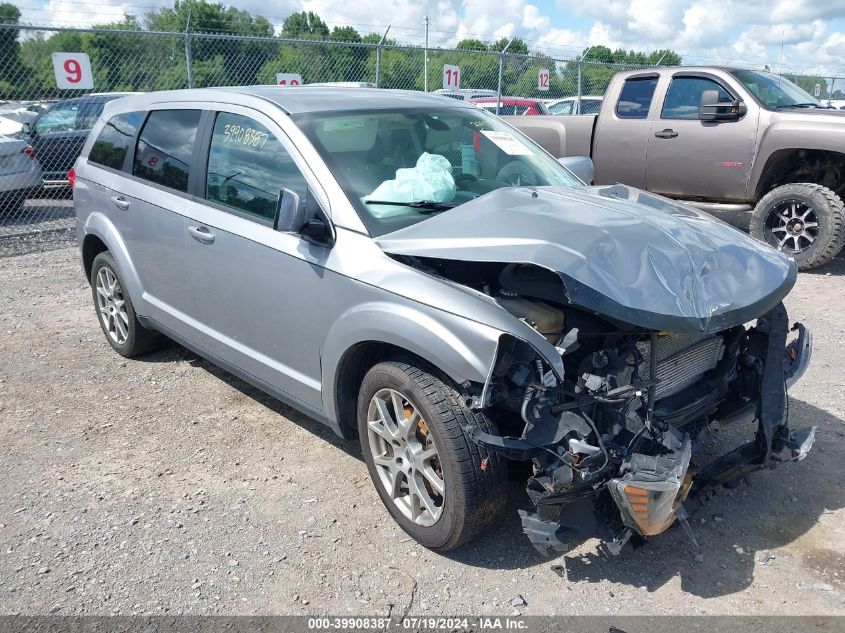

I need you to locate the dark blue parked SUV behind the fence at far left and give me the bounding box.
[20,92,133,187]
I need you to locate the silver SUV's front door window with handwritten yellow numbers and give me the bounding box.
[205,112,307,222]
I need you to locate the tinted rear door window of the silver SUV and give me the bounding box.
[132,110,201,191]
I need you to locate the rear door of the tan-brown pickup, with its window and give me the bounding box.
[593,73,658,188]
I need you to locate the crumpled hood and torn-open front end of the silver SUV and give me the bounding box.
[379,186,815,554]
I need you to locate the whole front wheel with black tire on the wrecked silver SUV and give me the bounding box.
[358,359,508,551]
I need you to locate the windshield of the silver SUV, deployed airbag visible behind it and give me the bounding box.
[293,107,581,236]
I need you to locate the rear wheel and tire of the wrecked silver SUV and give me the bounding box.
[91,251,165,358]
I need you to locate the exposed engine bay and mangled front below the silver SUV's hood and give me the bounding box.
[402,257,815,554]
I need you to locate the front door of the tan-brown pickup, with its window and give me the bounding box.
[646,73,757,201]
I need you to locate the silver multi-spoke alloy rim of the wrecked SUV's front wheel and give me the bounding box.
[367,389,446,527]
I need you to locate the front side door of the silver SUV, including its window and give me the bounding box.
[185,106,329,408]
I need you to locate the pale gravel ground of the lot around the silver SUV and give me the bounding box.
[0,248,845,615]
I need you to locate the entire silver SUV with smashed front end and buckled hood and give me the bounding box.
[76,86,814,553]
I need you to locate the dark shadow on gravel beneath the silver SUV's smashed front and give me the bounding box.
[447,400,845,598]
